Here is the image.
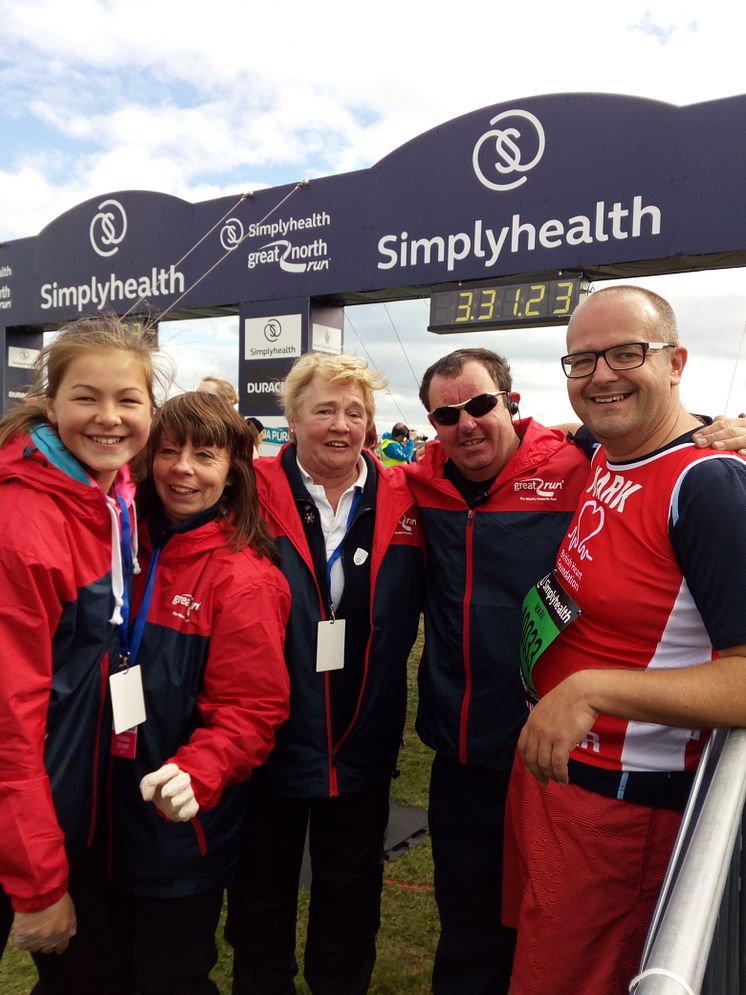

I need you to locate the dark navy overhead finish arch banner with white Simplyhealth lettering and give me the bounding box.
[0,93,746,325]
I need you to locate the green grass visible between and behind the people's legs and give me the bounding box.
[0,632,438,995]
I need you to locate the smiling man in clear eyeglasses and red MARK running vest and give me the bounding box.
[505,287,746,995]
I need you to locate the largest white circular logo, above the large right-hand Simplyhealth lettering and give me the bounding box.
[471,109,545,190]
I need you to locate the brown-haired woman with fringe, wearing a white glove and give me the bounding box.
[112,392,290,995]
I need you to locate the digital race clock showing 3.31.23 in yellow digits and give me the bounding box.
[427,276,588,334]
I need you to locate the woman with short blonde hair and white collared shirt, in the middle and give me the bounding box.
[226,354,423,995]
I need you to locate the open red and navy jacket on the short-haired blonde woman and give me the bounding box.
[254,444,423,798]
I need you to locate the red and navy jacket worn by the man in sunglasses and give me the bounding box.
[400,418,588,770]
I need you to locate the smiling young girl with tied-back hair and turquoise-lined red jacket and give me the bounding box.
[0,317,161,995]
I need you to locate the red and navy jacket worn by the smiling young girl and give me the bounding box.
[0,425,132,912]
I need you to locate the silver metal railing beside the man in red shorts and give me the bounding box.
[630,729,746,995]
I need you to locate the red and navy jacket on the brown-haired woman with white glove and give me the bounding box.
[112,508,290,898]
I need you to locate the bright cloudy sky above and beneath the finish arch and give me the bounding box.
[0,0,746,429]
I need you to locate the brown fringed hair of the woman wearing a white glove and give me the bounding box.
[138,391,277,560]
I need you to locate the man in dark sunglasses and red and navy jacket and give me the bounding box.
[405,349,588,995]
